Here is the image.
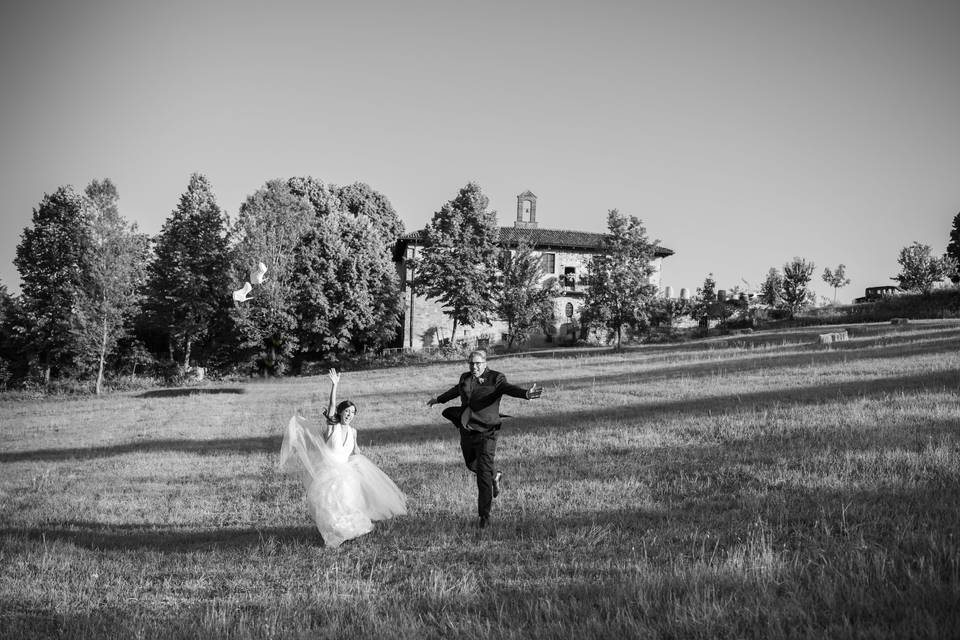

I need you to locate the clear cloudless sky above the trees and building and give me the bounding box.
[0,0,960,302]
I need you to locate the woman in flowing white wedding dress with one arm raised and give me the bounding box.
[280,369,407,548]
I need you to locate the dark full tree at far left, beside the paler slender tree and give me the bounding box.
[14,186,89,382]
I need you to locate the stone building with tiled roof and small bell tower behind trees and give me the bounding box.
[393,191,673,350]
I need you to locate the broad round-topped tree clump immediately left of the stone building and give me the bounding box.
[233,177,402,373]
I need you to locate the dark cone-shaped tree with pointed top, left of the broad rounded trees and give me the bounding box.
[145,173,230,368]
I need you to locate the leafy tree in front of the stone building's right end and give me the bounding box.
[584,209,657,349]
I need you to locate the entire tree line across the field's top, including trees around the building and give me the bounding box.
[0,174,960,393]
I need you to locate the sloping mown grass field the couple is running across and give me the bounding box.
[0,321,960,639]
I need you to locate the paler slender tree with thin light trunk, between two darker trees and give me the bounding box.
[74,179,148,395]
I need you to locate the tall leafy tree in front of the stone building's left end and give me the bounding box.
[413,182,500,336]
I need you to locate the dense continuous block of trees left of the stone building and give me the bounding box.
[0,174,403,392]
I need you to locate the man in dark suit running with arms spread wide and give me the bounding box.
[427,351,543,528]
